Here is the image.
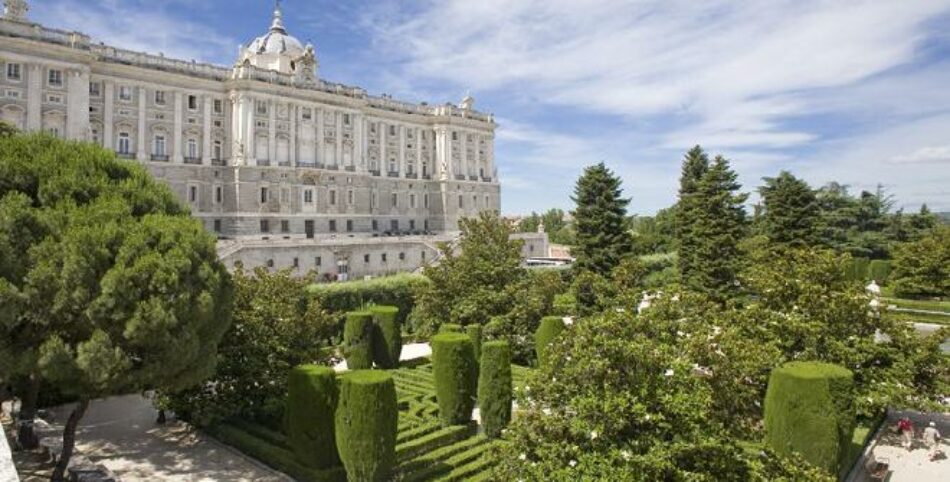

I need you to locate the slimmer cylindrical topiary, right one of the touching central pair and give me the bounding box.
[478,341,512,438]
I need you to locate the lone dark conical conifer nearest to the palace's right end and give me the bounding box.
[571,163,632,276]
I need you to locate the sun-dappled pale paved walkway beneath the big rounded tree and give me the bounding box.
[48,395,291,482]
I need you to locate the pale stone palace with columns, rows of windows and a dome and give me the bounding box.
[0,0,512,274]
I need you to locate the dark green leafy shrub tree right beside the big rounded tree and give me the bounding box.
[164,269,336,426]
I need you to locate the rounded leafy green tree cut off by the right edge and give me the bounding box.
[891,226,950,298]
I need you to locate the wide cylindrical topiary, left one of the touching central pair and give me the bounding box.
[432,333,478,425]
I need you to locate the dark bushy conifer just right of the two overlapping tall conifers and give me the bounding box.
[759,171,819,247]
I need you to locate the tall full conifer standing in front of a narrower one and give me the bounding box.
[681,156,748,301]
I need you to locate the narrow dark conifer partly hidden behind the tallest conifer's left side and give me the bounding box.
[674,146,709,284]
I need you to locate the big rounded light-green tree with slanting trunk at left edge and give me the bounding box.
[0,131,231,480]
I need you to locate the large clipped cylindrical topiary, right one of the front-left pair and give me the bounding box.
[334,370,398,482]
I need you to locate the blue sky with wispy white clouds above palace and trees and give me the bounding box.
[29,0,950,214]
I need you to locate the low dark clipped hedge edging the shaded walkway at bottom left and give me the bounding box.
[208,424,346,482]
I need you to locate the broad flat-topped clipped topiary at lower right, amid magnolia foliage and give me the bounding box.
[765,362,855,474]
